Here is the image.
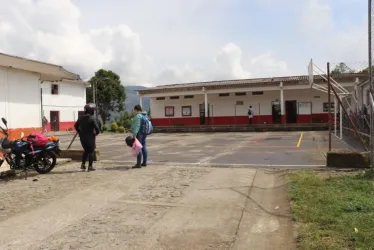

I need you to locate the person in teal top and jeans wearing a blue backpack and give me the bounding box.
[131,105,148,168]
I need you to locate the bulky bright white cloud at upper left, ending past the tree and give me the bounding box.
[0,0,148,84]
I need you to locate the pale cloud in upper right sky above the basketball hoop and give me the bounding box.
[301,0,368,65]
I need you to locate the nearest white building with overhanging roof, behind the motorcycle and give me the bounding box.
[0,53,80,138]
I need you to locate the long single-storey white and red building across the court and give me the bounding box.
[138,73,367,126]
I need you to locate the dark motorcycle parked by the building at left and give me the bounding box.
[0,118,61,174]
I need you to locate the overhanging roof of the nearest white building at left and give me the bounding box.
[0,53,80,81]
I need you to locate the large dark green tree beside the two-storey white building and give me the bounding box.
[86,69,126,123]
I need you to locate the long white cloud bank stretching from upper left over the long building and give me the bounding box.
[0,0,287,86]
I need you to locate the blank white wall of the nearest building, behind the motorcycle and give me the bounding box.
[0,67,41,128]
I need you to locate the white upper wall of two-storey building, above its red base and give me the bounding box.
[42,81,86,122]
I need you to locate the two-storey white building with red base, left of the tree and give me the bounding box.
[41,80,90,131]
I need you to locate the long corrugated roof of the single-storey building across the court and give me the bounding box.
[137,73,368,94]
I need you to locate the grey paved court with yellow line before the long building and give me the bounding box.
[60,132,348,168]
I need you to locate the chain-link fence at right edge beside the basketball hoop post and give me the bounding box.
[327,62,371,151]
